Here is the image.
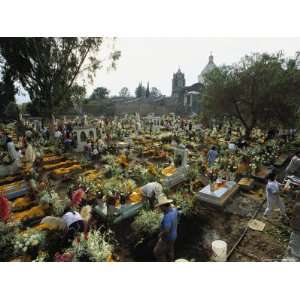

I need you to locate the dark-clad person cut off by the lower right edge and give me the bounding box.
[288,202,300,258]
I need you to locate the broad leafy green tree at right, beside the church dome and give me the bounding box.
[201,52,300,137]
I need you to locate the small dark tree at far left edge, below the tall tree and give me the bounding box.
[0,65,18,117]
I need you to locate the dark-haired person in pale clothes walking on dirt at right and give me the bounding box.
[264,172,288,220]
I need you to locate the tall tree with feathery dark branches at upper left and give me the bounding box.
[0,37,120,117]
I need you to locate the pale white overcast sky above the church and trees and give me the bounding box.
[17,37,300,103]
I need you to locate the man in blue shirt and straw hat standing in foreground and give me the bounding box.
[153,195,178,262]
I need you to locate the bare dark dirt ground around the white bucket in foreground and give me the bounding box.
[110,184,293,262]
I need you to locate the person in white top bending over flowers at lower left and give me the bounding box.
[62,207,85,242]
